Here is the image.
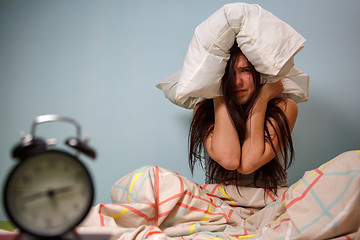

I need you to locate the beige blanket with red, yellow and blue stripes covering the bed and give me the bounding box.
[78,151,360,239]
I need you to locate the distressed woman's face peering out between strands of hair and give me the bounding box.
[234,54,255,105]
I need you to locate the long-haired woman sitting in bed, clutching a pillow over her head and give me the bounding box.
[189,42,297,192]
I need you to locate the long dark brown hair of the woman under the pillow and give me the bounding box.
[188,42,294,193]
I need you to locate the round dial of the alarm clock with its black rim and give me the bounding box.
[4,150,94,237]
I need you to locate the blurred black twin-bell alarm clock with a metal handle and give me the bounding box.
[3,115,96,239]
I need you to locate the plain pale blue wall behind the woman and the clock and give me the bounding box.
[0,0,360,220]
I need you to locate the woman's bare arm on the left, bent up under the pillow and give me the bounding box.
[205,97,241,170]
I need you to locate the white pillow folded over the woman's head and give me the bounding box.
[157,3,309,108]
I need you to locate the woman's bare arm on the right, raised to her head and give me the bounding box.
[237,81,298,174]
